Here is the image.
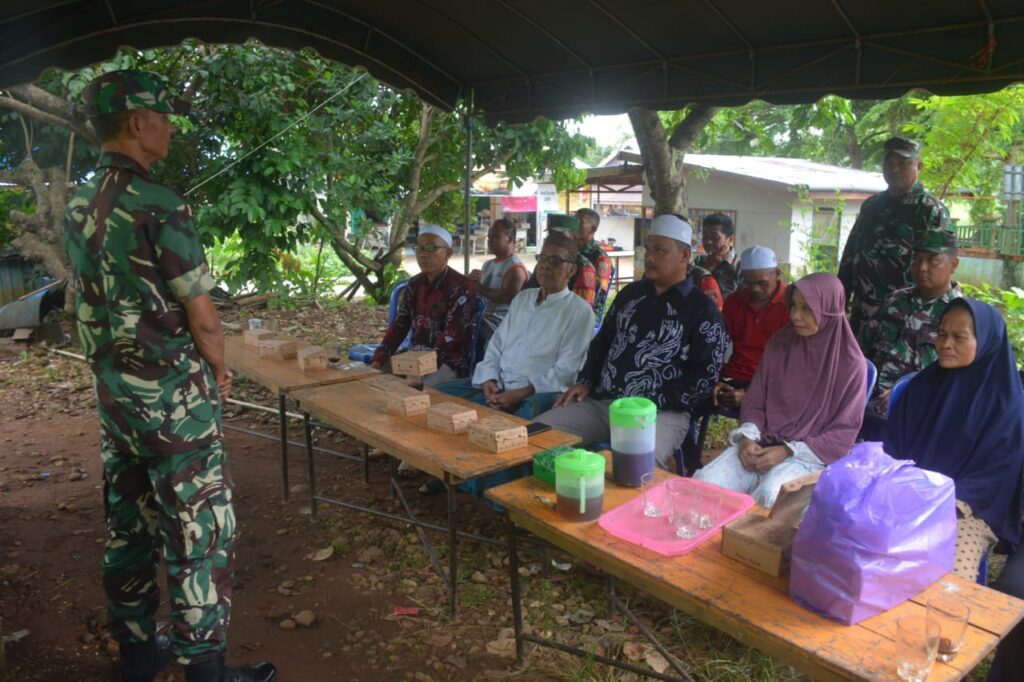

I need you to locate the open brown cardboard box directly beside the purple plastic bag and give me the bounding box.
[722,472,821,578]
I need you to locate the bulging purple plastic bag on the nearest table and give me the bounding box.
[790,442,956,625]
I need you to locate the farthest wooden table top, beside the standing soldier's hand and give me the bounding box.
[224,334,380,393]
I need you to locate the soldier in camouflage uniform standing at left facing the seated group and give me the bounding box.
[65,71,276,682]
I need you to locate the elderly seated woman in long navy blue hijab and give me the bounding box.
[885,298,1024,681]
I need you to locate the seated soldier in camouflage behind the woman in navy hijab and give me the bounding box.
[857,229,964,440]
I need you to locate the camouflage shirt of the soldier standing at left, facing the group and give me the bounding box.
[65,153,221,457]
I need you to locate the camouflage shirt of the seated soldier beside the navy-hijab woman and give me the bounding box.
[857,282,964,391]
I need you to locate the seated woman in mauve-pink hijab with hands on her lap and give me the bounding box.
[695,272,867,507]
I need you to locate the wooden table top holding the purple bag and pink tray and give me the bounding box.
[486,458,1024,682]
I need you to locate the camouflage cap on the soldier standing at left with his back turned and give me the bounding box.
[84,69,191,118]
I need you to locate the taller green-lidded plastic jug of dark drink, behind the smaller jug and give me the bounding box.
[608,397,657,487]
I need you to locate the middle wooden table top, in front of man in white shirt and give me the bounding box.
[291,374,580,480]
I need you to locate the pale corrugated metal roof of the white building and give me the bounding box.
[684,154,886,193]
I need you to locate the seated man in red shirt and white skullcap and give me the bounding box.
[714,246,790,410]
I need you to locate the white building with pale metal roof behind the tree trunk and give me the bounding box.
[579,150,886,273]
